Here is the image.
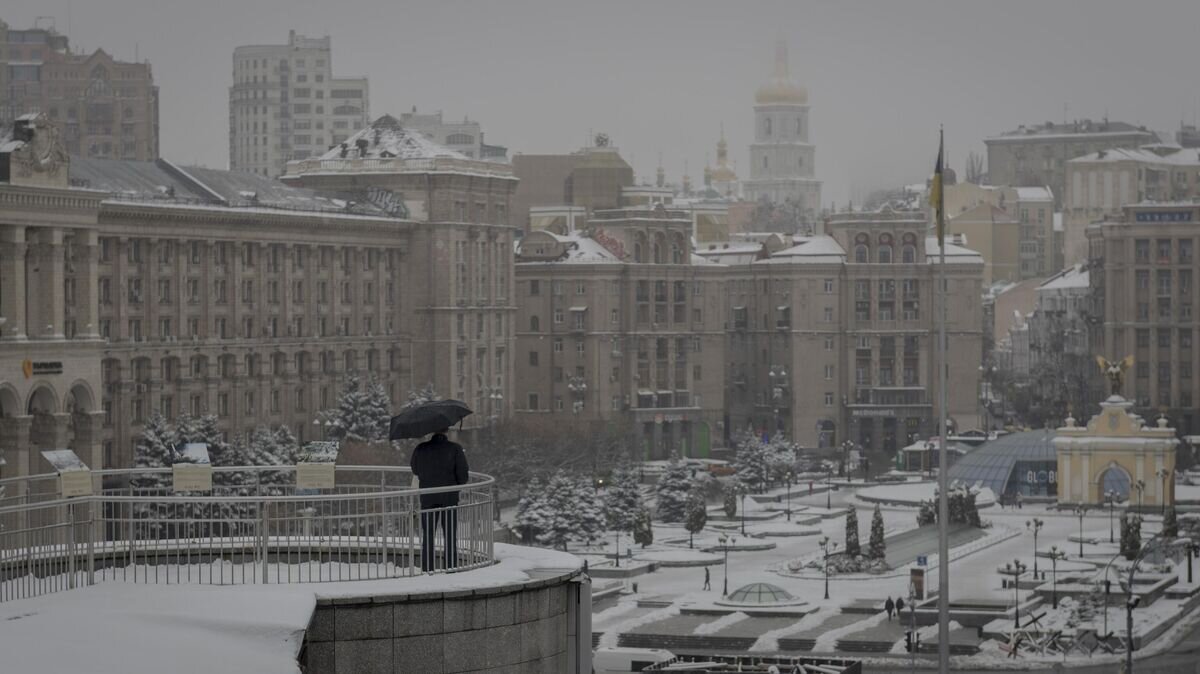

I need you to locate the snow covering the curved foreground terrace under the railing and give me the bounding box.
[0,544,581,674]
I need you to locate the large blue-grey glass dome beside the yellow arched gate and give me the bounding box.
[948,429,1058,497]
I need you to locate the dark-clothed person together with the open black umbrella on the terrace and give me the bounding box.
[389,401,470,572]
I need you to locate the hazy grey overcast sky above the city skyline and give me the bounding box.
[0,0,1200,205]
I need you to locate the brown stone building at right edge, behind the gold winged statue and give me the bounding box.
[1087,203,1200,435]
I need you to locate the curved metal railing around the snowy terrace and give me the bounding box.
[0,465,494,602]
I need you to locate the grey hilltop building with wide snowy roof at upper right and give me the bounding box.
[984,119,1159,207]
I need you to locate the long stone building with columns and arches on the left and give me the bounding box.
[0,112,516,476]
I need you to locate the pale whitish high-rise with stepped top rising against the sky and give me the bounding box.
[229,30,371,177]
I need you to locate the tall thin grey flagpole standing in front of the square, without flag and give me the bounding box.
[936,130,950,674]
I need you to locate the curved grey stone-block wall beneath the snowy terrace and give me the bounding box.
[300,574,588,674]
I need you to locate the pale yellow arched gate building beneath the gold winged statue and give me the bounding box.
[1054,395,1178,506]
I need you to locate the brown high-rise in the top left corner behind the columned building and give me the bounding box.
[0,22,158,161]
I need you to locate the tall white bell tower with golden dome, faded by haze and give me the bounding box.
[742,37,821,224]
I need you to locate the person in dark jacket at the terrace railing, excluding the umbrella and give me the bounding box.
[409,428,468,572]
